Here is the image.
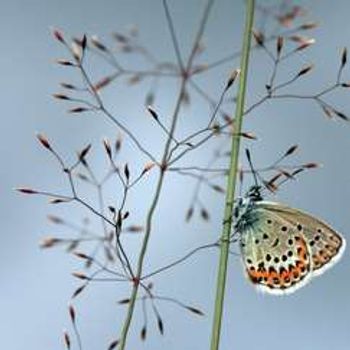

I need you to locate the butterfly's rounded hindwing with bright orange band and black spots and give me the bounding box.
[240,208,312,295]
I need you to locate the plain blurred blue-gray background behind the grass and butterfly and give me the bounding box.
[0,0,350,350]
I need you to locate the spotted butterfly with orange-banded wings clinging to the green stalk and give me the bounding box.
[234,184,346,295]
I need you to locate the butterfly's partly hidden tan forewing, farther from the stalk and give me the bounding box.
[260,202,346,276]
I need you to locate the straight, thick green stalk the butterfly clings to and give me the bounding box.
[210,0,255,350]
